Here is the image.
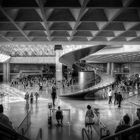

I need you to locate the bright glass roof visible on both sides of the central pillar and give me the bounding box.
[0,43,89,57]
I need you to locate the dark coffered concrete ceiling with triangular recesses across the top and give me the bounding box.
[0,0,140,43]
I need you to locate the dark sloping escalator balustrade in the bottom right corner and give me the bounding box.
[102,124,140,140]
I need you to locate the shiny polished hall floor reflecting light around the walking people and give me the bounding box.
[0,84,140,140]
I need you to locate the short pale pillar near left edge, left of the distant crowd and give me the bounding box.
[3,62,10,83]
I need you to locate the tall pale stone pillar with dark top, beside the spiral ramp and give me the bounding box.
[54,45,63,82]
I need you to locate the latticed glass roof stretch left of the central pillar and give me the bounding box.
[0,44,55,56]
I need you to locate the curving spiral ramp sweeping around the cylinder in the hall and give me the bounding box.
[60,45,115,98]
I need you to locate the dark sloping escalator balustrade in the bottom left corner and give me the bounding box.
[0,123,29,140]
